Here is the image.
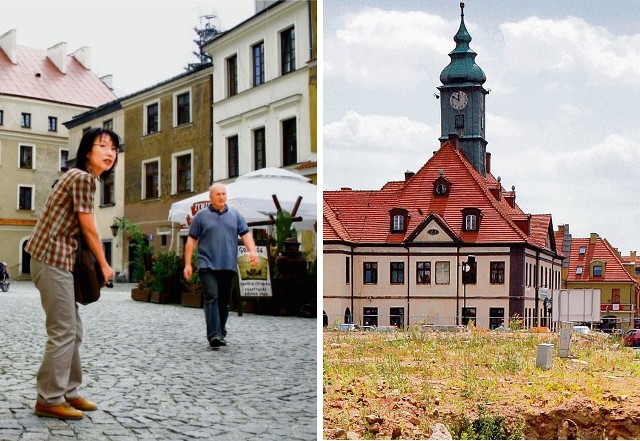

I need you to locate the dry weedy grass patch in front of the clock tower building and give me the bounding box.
[323,327,640,439]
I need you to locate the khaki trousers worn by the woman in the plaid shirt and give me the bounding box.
[31,259,82,406]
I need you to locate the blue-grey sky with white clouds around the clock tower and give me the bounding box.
[322,0,640,254]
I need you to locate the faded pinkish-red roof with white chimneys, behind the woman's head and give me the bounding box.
[0,46,117,107]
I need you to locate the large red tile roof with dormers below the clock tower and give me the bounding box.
[323,140,556,251]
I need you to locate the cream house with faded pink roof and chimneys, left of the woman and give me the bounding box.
[0,30,116,279]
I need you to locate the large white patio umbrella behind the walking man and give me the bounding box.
[169,167,318,230]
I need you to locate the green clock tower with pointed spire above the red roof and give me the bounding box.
[438,2,489,176]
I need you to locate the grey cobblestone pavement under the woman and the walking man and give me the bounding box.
[0,282,318,441]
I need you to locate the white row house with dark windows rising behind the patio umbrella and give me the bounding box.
[205,1,317,182]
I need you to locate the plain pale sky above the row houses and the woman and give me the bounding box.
[0,0,255,94]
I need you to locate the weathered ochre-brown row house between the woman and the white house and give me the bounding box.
[67,63,212,281]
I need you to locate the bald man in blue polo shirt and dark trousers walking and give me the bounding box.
[183,183,258,349]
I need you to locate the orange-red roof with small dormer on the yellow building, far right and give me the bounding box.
[567,237,634,283]
